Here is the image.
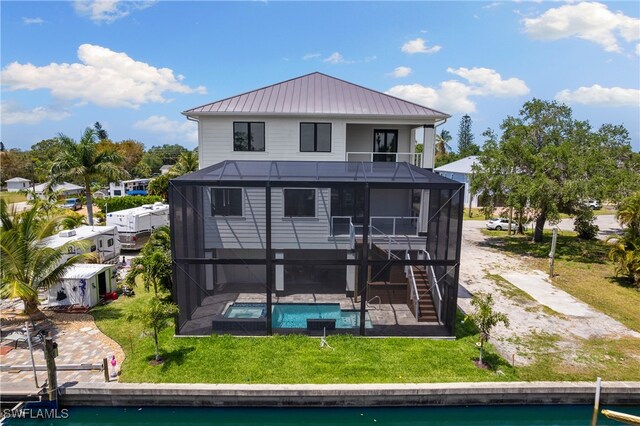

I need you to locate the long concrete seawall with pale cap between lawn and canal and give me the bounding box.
[60,382,640,407]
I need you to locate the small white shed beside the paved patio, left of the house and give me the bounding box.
[49,264,116,308]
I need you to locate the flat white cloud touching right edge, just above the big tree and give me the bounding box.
[555,84,640,107]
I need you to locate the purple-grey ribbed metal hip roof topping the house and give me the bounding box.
[183,72,449,120]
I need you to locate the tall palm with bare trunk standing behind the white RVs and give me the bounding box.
[51,127,128,225]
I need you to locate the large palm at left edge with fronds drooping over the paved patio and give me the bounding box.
[0,200,95,315]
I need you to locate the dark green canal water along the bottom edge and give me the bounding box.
[5,405,640,426]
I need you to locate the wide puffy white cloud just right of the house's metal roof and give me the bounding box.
[386,68,529,114]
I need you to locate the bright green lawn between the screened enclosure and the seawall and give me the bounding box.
[92,289,517,383]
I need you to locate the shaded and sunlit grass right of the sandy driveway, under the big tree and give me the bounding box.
[483,230,640,332]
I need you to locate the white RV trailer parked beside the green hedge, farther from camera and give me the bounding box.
[107,202,169,250]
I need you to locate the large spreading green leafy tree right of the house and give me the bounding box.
[472,99,638,242]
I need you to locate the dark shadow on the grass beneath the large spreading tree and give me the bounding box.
[479,231,609,264]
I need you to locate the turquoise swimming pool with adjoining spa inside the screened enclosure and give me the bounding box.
[224,303,373,329]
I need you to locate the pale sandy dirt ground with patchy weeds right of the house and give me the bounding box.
[458,222,640,365]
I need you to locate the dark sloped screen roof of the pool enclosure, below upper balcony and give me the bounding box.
[171,160,460,187]
